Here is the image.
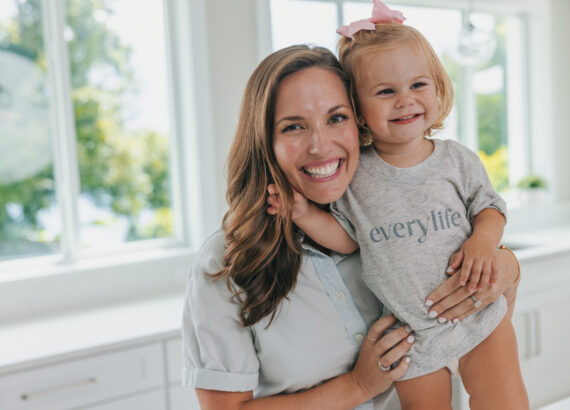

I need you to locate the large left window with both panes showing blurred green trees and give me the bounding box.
[0,0,193,260]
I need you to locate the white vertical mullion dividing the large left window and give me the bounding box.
[42,0,79,261]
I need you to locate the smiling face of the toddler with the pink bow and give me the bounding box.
[356,44,439,151]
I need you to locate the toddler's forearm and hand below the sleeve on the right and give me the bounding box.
[451,208,505,292]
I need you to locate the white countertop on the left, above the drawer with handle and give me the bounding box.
[0,294,183,374]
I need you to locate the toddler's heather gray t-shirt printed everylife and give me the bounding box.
[331,139,506,380]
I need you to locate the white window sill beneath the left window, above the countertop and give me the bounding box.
[0,248,194,324]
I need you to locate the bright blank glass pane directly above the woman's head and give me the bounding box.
[271,0,338,52]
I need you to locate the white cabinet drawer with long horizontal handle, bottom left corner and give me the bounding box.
[0,344,164,410]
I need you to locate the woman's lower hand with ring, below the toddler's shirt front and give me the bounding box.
[351,315,414,400]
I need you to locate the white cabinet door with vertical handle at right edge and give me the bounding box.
[515,288,570,408]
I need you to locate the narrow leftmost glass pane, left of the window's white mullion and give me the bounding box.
[0,0,61,260]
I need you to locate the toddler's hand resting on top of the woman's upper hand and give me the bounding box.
[450,233,497,292]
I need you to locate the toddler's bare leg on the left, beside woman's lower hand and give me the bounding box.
[395,368,451,410]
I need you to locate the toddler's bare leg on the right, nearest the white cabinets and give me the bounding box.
[459,317,529,410]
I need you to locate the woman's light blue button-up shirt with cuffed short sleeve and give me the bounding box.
[182,231,400,410]
